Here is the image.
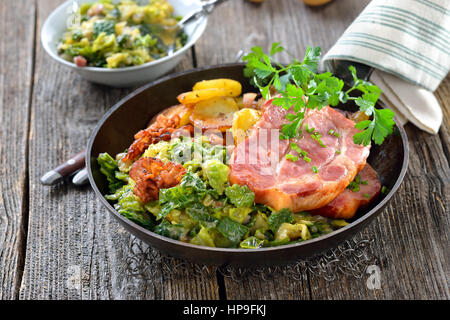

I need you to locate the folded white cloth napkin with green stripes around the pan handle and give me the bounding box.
[322,0,450,134]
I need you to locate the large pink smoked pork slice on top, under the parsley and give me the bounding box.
[230,100,370,212]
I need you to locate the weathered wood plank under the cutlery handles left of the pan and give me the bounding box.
[20,0,218,299]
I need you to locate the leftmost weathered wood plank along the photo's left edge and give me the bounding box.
[0,0,35,299]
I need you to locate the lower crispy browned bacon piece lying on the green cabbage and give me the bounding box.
[130,158,186,203]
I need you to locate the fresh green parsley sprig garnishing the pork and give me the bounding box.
[244,43,394,148]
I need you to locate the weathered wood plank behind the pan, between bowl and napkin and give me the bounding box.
[196,0,369,66]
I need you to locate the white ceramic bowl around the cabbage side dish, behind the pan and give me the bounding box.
[41,0,207,87]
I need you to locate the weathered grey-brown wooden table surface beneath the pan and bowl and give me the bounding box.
[0,0,450,300]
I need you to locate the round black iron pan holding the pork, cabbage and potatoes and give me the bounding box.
[86,64,408,266]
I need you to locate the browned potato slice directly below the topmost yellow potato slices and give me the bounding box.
[190,97,239,132]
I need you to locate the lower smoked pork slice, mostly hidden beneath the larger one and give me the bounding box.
[310,164,381,219]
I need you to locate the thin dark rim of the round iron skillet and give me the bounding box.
[86,63,409,254]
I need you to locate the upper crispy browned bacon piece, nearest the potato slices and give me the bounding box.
[122,114,180,164]
